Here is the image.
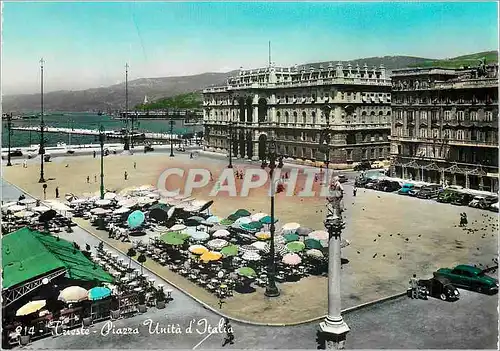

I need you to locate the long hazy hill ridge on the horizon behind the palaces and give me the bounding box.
[3,51,498,113]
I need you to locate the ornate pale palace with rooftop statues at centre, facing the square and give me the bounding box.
[203,64,391,164]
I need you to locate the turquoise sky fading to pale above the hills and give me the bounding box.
[1,2,498,95]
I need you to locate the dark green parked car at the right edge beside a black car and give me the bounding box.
[434,264,498,293]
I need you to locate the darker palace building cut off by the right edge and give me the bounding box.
[391,65,498,192]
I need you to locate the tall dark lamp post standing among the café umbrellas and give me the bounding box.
[264,139,280,297]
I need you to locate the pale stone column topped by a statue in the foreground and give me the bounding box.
[320,177,350,350]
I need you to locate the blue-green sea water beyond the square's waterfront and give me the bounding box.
[2,112,203,148]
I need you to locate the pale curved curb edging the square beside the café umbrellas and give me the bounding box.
[3,179,406,327]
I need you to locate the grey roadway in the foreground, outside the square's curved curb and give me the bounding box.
[2,180,498,349]
